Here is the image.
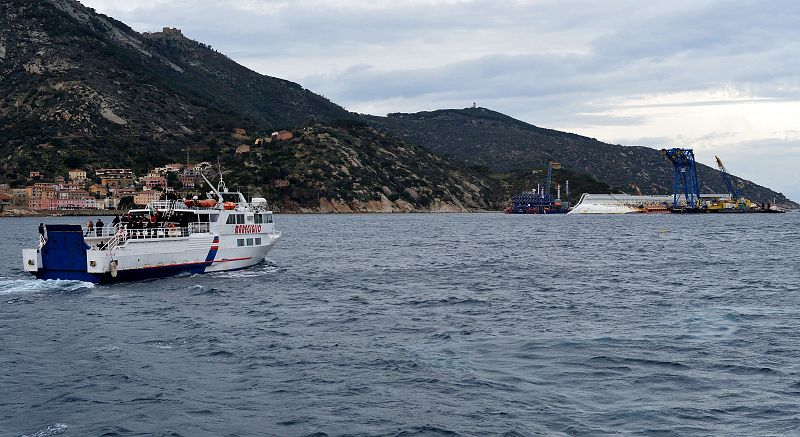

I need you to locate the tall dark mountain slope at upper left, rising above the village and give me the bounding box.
[0,0,350,181]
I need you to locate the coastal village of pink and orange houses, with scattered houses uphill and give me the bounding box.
[0,128,293,215]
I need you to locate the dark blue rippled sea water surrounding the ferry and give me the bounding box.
[0,213,800,436]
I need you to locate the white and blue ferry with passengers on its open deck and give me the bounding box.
[22,177,281,283]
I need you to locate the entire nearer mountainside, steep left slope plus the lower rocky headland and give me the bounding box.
[0,0,497,212]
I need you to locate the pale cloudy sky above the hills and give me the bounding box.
[81,0,800,201]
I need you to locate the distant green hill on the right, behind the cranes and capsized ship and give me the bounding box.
[370,108,796,206]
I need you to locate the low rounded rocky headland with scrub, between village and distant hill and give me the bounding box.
[230,122,497,212]
